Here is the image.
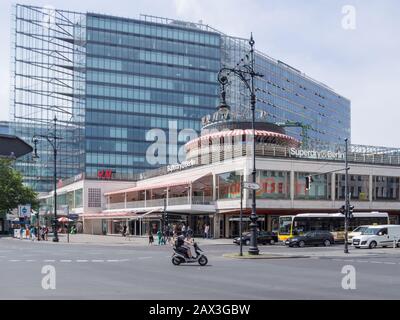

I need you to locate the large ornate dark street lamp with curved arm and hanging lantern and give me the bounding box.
[218,34,263,255]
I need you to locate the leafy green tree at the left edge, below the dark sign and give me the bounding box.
[0,159,39,214]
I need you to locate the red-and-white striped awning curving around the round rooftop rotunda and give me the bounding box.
[186,129,300,147]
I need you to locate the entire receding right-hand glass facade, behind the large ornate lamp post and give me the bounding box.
[221,36,351,150]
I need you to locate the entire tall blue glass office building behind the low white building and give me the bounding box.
[11,5,350,191]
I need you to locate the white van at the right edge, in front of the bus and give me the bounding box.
[353,224,400,249]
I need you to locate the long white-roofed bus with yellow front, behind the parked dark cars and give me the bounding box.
[278,212,389,241]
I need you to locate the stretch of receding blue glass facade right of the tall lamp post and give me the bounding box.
[256,54,350,150]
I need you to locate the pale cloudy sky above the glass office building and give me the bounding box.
[0,0,400,147]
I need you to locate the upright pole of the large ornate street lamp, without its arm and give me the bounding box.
[248,34,259,255]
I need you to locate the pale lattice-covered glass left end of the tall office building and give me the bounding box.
[10,4,86,191]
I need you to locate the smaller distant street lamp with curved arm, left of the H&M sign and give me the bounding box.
[32,117,62,242]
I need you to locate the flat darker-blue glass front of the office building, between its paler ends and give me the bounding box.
[85,14,220,178]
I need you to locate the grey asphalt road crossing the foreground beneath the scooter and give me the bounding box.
[0,238,400,299]
